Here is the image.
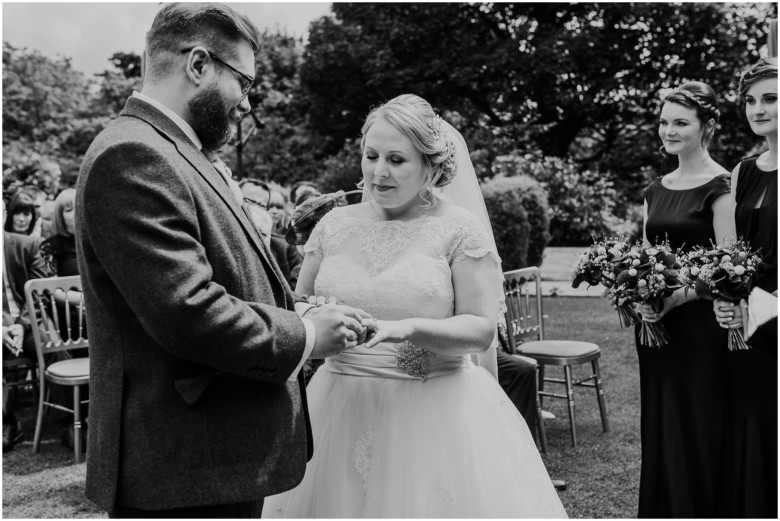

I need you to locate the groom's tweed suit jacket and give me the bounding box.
[76,98,312,510]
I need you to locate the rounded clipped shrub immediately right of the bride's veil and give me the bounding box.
[482,176,549,271]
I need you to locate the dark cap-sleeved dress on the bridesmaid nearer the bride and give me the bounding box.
[637,175,729,518]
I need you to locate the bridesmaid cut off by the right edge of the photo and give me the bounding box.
[715,58,777,518]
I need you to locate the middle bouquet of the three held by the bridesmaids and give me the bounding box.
[611,240,683,347]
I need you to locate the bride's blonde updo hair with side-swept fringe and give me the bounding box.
[360,94,457,207]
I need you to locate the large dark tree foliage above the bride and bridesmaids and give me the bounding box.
[301,3,774,205]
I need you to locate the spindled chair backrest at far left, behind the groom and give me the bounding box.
[24,275,89,367]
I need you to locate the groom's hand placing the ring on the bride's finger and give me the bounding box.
[306,304,370,358]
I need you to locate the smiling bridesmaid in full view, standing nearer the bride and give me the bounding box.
[637,82,734,518]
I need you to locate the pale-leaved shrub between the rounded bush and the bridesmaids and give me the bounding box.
[494,154,617,246]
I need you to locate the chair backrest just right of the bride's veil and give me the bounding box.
[504,266,544,354]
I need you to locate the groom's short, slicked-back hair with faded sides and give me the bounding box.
[145,2,260,78]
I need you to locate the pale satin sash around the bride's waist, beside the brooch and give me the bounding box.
[321,344,474,380]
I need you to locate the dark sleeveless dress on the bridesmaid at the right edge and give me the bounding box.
[722,158,777,518]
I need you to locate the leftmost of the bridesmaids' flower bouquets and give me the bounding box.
[571,237,641,327]
